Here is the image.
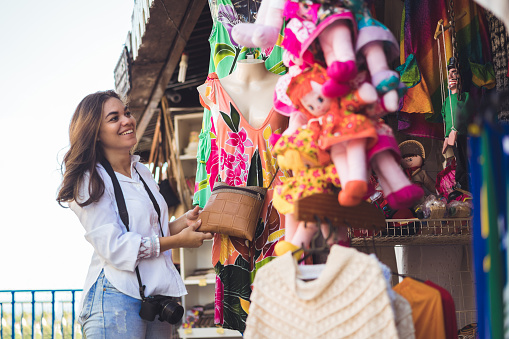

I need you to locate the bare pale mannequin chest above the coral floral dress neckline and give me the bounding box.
[197,59,279,128]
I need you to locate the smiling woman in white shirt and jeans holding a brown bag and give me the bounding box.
[57,91,212,339]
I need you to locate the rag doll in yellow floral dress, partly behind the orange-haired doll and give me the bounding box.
[272,127,347,257]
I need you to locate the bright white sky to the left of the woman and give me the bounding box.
[0,0,134,290]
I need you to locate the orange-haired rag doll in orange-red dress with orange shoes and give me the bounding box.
[288,64,378,206]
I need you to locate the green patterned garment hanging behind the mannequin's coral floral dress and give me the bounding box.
[193,0,286,207]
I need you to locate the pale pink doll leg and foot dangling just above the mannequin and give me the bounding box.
[232,0,284,48]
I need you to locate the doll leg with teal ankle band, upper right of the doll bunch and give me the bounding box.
[363,41,399,112]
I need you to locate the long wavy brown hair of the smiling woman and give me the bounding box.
[57,91,121,207]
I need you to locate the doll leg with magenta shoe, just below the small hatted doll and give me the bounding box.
[371,151,424,209]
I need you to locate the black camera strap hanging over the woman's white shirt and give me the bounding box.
[101,158,163,300]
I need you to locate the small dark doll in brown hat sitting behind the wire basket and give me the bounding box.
[399,140,436,203]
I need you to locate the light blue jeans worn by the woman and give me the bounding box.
[78,272,173,339]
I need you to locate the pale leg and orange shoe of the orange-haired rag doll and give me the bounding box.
[330,139,368,206]
